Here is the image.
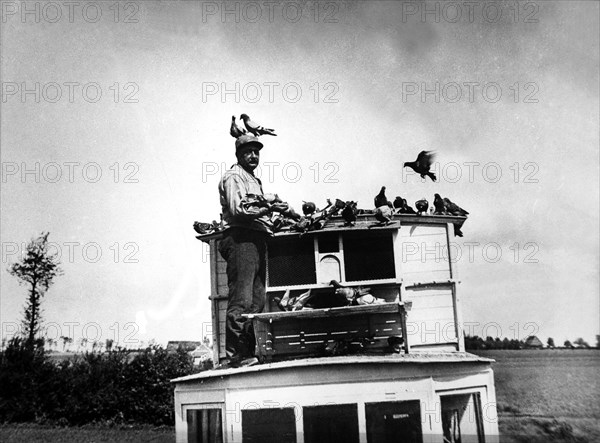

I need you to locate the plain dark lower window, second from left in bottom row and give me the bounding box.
[242,408,296,443]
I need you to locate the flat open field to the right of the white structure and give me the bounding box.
[476,349,600,442]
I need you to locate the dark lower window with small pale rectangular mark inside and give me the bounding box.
[365,400,423,443]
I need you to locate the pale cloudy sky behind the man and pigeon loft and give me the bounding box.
[0,1,600,347]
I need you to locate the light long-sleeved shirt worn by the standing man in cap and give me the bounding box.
[219,163,272,234]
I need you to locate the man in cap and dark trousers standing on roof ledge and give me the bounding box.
[219,134,288,367]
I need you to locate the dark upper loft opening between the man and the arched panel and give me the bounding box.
[267,236,317,286]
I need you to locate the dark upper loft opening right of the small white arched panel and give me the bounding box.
[343,231,396,281]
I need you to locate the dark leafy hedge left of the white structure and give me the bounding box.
[0,338,202,425]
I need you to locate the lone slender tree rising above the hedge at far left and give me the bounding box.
[8,232,62,348]
